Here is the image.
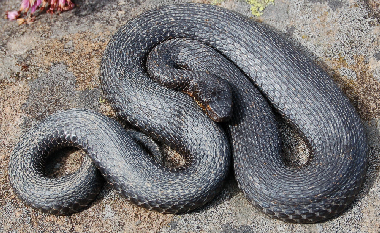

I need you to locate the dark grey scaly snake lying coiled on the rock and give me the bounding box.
[9,4,367,223]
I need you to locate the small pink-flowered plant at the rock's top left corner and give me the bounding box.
[6,0,75,24]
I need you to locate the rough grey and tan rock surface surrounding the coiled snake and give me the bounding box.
[0,0,380,232]
